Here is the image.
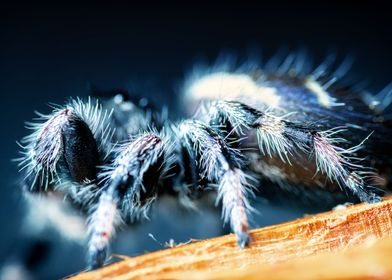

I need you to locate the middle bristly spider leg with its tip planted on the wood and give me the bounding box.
[177,121,251,248]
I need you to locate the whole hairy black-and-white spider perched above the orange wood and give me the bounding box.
[19,54,392,269]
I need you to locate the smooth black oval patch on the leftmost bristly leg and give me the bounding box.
[63,118,99,183]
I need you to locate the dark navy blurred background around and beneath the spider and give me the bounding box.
[0,1,392,279]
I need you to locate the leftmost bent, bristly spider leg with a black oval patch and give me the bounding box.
[19,100,110,197]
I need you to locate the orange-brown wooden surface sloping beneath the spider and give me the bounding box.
[72,198,392,279]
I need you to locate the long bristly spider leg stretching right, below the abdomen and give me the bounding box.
[211,101,380,202]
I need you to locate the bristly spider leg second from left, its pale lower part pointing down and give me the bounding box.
[88,133,171,269]
